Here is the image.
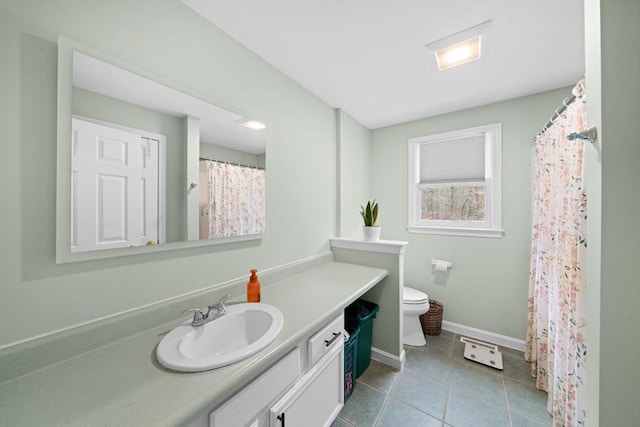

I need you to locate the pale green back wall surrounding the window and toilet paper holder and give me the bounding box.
[372,88,571,340]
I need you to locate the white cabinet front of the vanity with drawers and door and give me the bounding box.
[204,314,344,427]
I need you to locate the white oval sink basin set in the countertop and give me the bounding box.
[156,303,283,372]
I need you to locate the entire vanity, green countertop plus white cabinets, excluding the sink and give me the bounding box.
[0,261,388,427]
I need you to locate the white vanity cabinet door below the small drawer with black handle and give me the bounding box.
[270,339,344,427]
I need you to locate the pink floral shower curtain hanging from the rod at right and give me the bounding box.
[525,86,587,427]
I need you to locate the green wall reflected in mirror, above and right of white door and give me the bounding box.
[72,88,187,242]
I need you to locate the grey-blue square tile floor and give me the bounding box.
[331,331,552,427]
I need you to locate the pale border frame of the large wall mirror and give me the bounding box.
[56,35,266,264]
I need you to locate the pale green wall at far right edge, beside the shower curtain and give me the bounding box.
[585,0,640,427]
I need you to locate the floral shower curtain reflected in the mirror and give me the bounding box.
[207,160,266,239]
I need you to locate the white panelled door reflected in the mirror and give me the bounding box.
[71,118,164,252]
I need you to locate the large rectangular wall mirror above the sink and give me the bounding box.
[56,37,266,262]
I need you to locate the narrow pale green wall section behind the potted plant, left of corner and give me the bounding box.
[336,110,372,238]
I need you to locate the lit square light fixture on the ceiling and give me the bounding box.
[426,20,491,71]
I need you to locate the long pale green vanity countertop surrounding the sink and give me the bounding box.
[0,262,387,426]
